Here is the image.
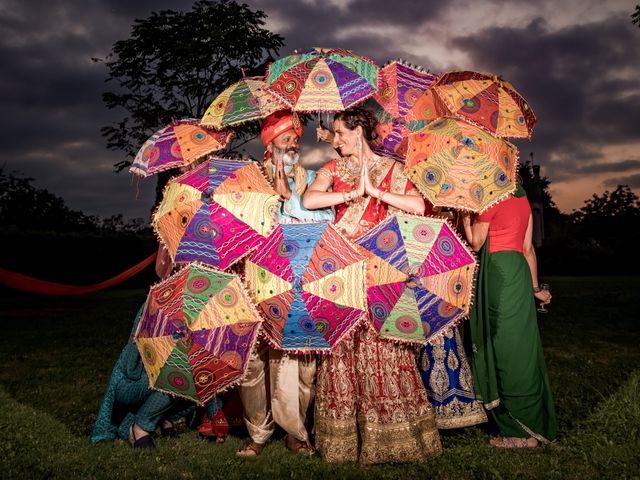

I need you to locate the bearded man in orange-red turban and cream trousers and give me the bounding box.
[238,111,334,456]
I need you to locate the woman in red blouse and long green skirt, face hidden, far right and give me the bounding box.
[464,187,557,448]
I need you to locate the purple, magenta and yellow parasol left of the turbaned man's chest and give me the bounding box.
[152,158,279,269]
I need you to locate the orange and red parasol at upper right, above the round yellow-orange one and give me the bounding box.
[432,71,537,139]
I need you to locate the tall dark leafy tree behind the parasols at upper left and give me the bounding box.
[99,0,283,171]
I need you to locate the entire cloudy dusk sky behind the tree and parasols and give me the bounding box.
[0,0,640,217]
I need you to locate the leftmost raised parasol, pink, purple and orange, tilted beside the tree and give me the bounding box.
[129,118,235,177]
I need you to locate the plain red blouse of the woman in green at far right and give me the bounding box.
[476,196,531,253]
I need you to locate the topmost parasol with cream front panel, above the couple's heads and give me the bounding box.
[265,48,378,112]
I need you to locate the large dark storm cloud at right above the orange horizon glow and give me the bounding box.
[452,15,640,179]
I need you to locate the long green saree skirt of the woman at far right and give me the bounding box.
[469,239,556,442]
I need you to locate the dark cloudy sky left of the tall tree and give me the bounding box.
[0,1,175,218]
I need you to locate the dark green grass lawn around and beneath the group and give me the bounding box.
[0,277,640,480]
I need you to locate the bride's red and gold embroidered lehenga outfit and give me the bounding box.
[315,157,442,464]
